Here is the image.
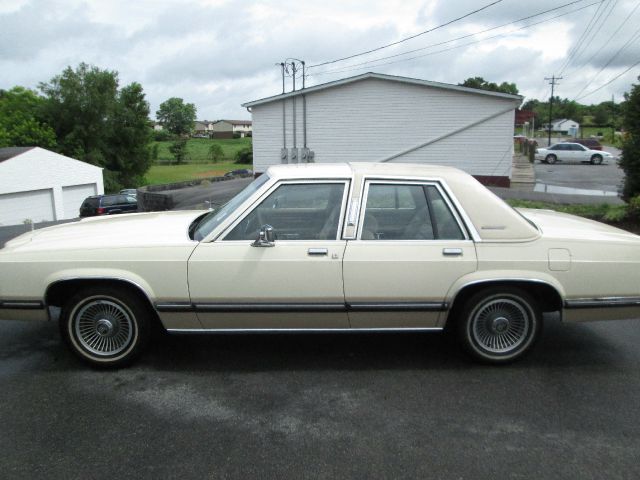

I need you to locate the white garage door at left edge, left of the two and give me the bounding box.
[0,188,55,225]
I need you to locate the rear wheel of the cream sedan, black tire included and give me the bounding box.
[457,287,542,364]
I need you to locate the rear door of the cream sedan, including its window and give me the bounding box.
[343,180,477,329]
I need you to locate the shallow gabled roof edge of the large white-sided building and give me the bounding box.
[242,72,524,107]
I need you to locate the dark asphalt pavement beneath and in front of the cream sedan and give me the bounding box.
[0,319,640,480]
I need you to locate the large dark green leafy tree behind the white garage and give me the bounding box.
[40,63,150,191]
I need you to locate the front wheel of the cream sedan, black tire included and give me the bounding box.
[60,286,150,368]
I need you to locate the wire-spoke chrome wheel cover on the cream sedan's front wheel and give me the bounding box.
[73,297,135,357]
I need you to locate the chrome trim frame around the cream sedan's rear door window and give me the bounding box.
[355,176,475,244]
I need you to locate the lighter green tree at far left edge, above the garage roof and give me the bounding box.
[0,87,56,149]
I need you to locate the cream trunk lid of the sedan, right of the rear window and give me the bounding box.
[516,208,640,245]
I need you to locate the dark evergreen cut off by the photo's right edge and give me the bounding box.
[620,77,640,201]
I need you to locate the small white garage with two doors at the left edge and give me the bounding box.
[0,147,104,225]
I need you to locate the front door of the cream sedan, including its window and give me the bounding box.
[189,180,349,330]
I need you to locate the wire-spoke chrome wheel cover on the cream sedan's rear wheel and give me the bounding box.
[471,298,531,354]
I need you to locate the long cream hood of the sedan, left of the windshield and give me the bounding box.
[5,210,204,250]
